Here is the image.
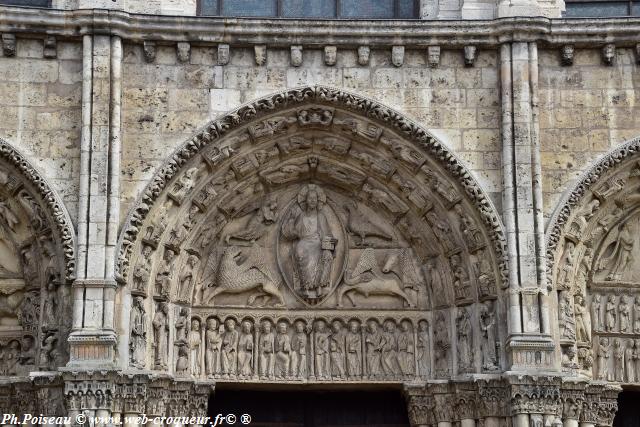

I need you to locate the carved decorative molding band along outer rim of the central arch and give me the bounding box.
[116,86,508,286]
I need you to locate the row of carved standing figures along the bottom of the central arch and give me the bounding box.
[130,296,499,381]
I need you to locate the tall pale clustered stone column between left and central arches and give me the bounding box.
[68,35,122,369]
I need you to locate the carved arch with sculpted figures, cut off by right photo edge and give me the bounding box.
[548,140,640,383]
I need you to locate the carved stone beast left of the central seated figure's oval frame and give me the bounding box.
[203,246,284,306]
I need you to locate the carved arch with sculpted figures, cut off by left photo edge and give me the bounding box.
[0,140,74,375]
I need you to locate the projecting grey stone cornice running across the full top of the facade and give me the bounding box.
[0,6,640,48]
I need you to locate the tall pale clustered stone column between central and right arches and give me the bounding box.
[500,42,555,370]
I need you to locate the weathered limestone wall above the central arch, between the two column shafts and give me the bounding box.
[121,45,502,222]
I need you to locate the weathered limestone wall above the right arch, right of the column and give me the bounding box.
[539,49,640,218]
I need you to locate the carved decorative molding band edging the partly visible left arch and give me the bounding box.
[0,139,76,281]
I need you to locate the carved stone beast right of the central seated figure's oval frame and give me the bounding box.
[337,248,415,307]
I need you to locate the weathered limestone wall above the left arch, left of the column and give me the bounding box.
[0,38,82,221]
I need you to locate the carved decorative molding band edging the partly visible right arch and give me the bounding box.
[545,138,640,275]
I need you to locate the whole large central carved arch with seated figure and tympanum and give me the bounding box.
[118,87,506,381]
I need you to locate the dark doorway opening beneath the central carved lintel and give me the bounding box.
[208,388,409,427]
